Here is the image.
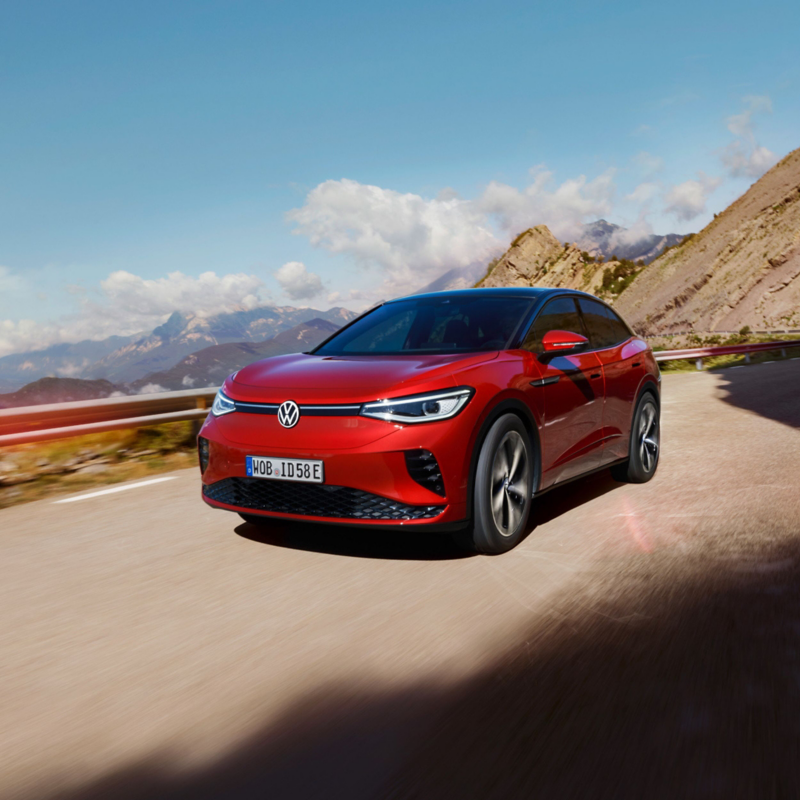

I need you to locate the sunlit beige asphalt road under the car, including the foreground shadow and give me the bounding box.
[0,360,800,800]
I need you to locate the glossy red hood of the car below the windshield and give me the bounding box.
[227,351,498,403]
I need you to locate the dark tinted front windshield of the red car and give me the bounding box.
[314,292,532,355]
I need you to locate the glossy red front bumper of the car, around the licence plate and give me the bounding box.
[200,413,474,528]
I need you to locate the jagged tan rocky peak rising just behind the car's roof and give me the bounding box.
[477,225,616,294]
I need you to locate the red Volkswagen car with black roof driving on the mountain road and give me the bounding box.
[199,288,661,553]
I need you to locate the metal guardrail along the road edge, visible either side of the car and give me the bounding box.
[0,341,800,447]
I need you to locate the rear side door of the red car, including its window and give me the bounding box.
[578,297,647,463]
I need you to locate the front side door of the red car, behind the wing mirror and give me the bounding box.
[522,295,603,488]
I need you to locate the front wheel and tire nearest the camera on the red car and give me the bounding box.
[467,414,535,554]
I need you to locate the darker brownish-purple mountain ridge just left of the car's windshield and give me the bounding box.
[131,318,341,392]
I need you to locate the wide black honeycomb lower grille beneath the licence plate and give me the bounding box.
[203,478,445,520]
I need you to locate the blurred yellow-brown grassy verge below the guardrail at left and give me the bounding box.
[0,422,197,509]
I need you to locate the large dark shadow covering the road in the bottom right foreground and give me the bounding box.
[45,529,800,800]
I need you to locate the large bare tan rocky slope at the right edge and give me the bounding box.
[615,150,800,334]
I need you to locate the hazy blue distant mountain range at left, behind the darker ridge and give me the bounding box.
[0,306,355,391]
